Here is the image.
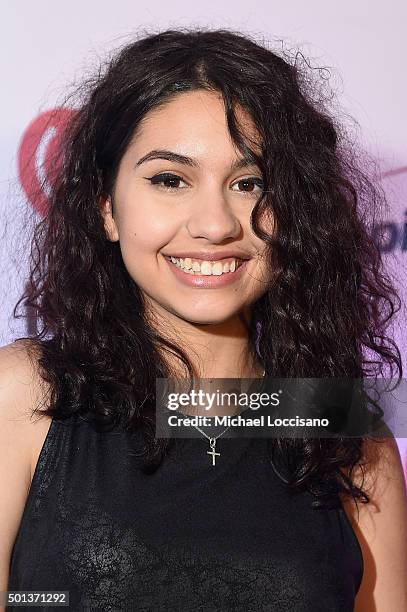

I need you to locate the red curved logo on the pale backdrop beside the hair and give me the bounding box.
[18,108,74,216]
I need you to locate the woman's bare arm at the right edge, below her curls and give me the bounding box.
[343,435,407,612]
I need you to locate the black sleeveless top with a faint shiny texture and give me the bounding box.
[6,416,363,612]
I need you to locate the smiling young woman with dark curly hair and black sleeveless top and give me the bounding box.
[0,30,407,612]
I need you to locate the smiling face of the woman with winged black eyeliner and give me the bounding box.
[102,90,268,324]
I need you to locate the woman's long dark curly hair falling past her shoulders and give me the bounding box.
[14,28,402,507]
